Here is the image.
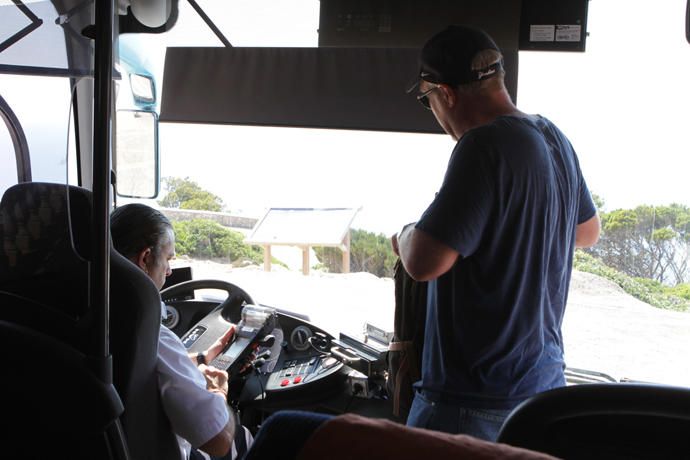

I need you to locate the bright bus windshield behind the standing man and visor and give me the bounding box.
[119,0,690,385]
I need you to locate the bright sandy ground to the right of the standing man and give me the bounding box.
[563,272,690,386]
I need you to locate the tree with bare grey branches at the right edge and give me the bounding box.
[588,204,690,285]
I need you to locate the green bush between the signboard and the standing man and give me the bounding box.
[314,229,396,277]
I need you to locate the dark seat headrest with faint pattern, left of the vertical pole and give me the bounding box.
[0,183,91,351]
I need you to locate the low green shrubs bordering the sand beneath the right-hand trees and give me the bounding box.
[573,250,690,311]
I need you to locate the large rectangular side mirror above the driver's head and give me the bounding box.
[113,110,160,199]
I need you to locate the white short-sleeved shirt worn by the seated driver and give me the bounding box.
[156,306,230,459]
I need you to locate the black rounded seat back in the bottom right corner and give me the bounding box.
[498,383,690,459]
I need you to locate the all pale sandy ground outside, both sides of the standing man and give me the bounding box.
[175,259,690,386]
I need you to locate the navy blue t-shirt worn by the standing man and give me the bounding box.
[416,116,596,409]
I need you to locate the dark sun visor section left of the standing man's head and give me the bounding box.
[160,48,442,133]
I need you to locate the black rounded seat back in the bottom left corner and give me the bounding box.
[0,320,126,459]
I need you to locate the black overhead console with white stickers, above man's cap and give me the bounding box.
[319,0,589,52]
